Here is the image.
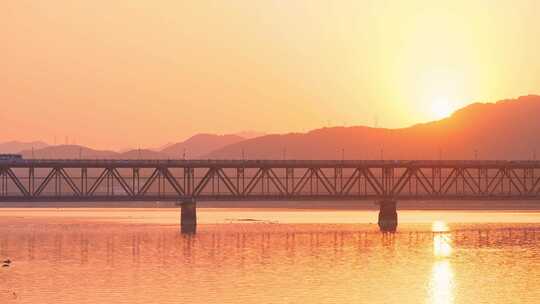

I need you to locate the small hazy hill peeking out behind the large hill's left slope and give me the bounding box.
[161,134,244,159]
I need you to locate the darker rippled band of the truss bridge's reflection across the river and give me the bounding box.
[0,224,540,268]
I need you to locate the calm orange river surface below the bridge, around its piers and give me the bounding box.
[0,209,540,303]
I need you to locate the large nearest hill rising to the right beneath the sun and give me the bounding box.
[204,95,540,159]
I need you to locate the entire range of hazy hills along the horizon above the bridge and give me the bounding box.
[10,95,540,160]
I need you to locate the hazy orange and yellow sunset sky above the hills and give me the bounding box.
[0,0,540,148]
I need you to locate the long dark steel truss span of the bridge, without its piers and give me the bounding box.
[0,159,540,202]
